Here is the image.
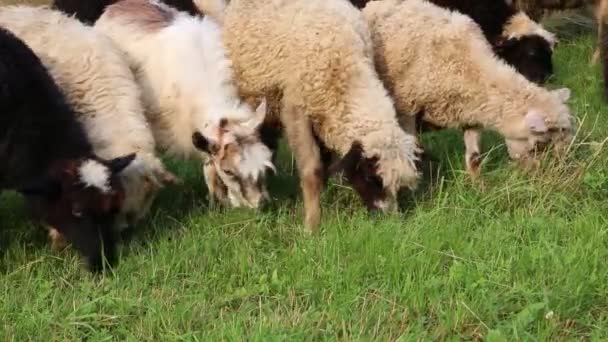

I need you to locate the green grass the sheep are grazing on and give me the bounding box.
[0,29,608,341]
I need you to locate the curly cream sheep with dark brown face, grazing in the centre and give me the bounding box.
[202,0,419,229]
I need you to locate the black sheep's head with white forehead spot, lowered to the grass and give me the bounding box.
[20,154,135,271]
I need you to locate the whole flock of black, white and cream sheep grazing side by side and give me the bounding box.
[0,0,592,270]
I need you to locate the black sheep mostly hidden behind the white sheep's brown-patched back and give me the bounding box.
[53,0,200,25]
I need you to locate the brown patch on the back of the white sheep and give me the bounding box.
[106,0,178,32]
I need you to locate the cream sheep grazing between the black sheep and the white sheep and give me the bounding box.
[0,6,177,229]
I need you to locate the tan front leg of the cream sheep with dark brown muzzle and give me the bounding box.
[280,101,323,232]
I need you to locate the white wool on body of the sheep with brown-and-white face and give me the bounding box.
[95,8,254,156]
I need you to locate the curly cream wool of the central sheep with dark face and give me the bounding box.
[216,0,419,191]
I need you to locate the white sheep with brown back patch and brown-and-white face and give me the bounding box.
[95,0,274,208]
